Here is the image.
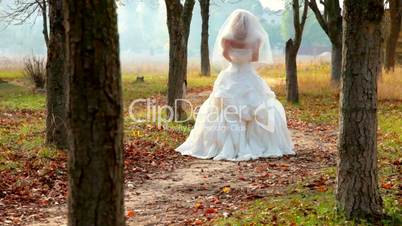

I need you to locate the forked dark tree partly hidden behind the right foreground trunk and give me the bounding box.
[308,0,342,84]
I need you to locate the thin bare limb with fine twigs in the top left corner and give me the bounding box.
[1,0,49,47]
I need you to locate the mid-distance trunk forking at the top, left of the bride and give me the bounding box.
[165,0,195,120]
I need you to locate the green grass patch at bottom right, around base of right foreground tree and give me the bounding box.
[214,191,402,226]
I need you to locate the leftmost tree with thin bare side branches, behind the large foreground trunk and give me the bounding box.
[2,0,67,148]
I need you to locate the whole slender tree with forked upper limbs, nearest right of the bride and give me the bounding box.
[285,0,308,103]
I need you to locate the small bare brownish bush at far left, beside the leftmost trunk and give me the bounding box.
[24,56,46,89]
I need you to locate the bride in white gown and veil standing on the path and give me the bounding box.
[176,10,294,161]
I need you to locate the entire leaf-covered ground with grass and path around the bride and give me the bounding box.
[0,65,402,225]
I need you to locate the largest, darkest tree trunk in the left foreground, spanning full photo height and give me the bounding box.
[64,0,125,226]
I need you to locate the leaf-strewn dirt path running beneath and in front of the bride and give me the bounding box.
[31,127,335,226]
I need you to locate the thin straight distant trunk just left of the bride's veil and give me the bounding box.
[199,0,211,76]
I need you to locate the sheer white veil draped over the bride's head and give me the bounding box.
[212,9,273,67]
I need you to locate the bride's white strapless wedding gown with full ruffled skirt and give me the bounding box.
[176,49,294,161]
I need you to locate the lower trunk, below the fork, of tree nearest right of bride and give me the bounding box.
[285,39,299,103]
